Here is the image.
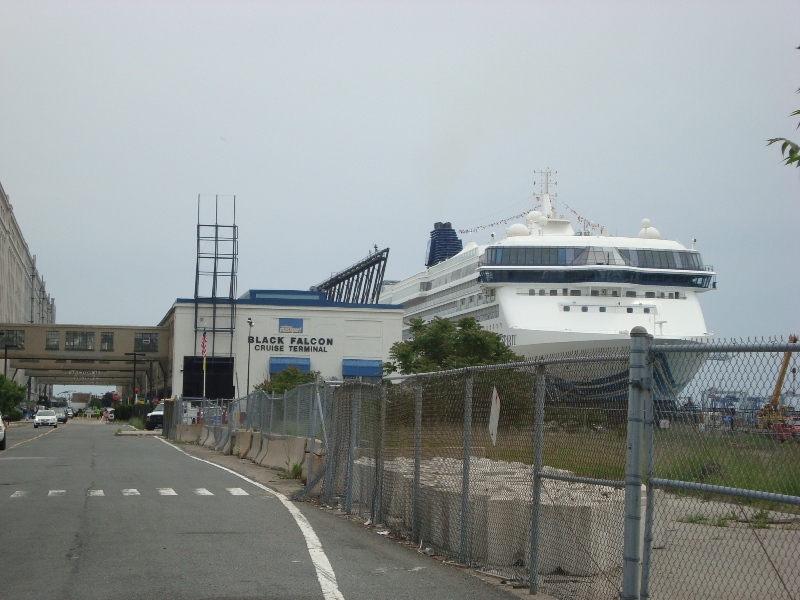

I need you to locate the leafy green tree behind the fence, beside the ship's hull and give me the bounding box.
[383,317,523,375]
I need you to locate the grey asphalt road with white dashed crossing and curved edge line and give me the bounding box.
[0,420,511,600]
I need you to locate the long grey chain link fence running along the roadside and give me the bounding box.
[165,332,800,599]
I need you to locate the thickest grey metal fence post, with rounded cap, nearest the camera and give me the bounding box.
[622,326,652,600]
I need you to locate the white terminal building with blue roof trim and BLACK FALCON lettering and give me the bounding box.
[159,290,403,398]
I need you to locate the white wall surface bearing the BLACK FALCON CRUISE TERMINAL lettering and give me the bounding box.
[162,302,403,396]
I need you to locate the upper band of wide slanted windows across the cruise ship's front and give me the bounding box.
[484,246,705,270]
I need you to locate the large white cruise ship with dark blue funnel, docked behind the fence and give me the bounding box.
[379,173,716,394]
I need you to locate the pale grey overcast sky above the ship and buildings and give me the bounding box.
[0,0,800,346]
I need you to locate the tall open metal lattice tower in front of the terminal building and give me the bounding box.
[194,194,239,357]
